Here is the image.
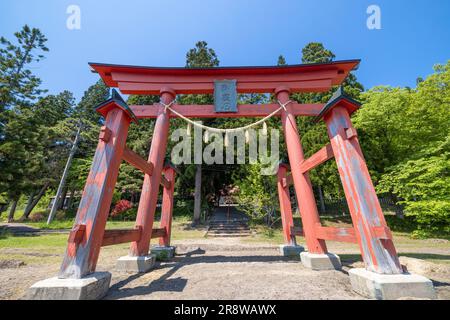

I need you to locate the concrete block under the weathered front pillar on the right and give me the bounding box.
[348,268,436,300]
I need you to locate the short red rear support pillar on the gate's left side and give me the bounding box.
[159,166,175,247]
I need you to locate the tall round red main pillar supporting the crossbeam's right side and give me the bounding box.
[275,87,327,254]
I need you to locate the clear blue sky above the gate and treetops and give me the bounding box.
[0,0,450,98]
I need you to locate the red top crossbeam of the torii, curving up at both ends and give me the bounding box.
[89,60,360,94]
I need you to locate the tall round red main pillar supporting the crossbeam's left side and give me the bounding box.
[130,88,175,256]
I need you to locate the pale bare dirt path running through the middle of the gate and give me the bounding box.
[106,245,361,300]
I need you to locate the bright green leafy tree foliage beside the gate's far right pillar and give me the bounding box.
[354,61,450,235]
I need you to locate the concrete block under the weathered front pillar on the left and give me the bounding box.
[25,272,111,300]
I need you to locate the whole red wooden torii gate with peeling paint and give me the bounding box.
[32,60,436,298]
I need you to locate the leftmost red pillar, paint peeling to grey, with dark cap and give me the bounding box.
[59,100,132,279]
